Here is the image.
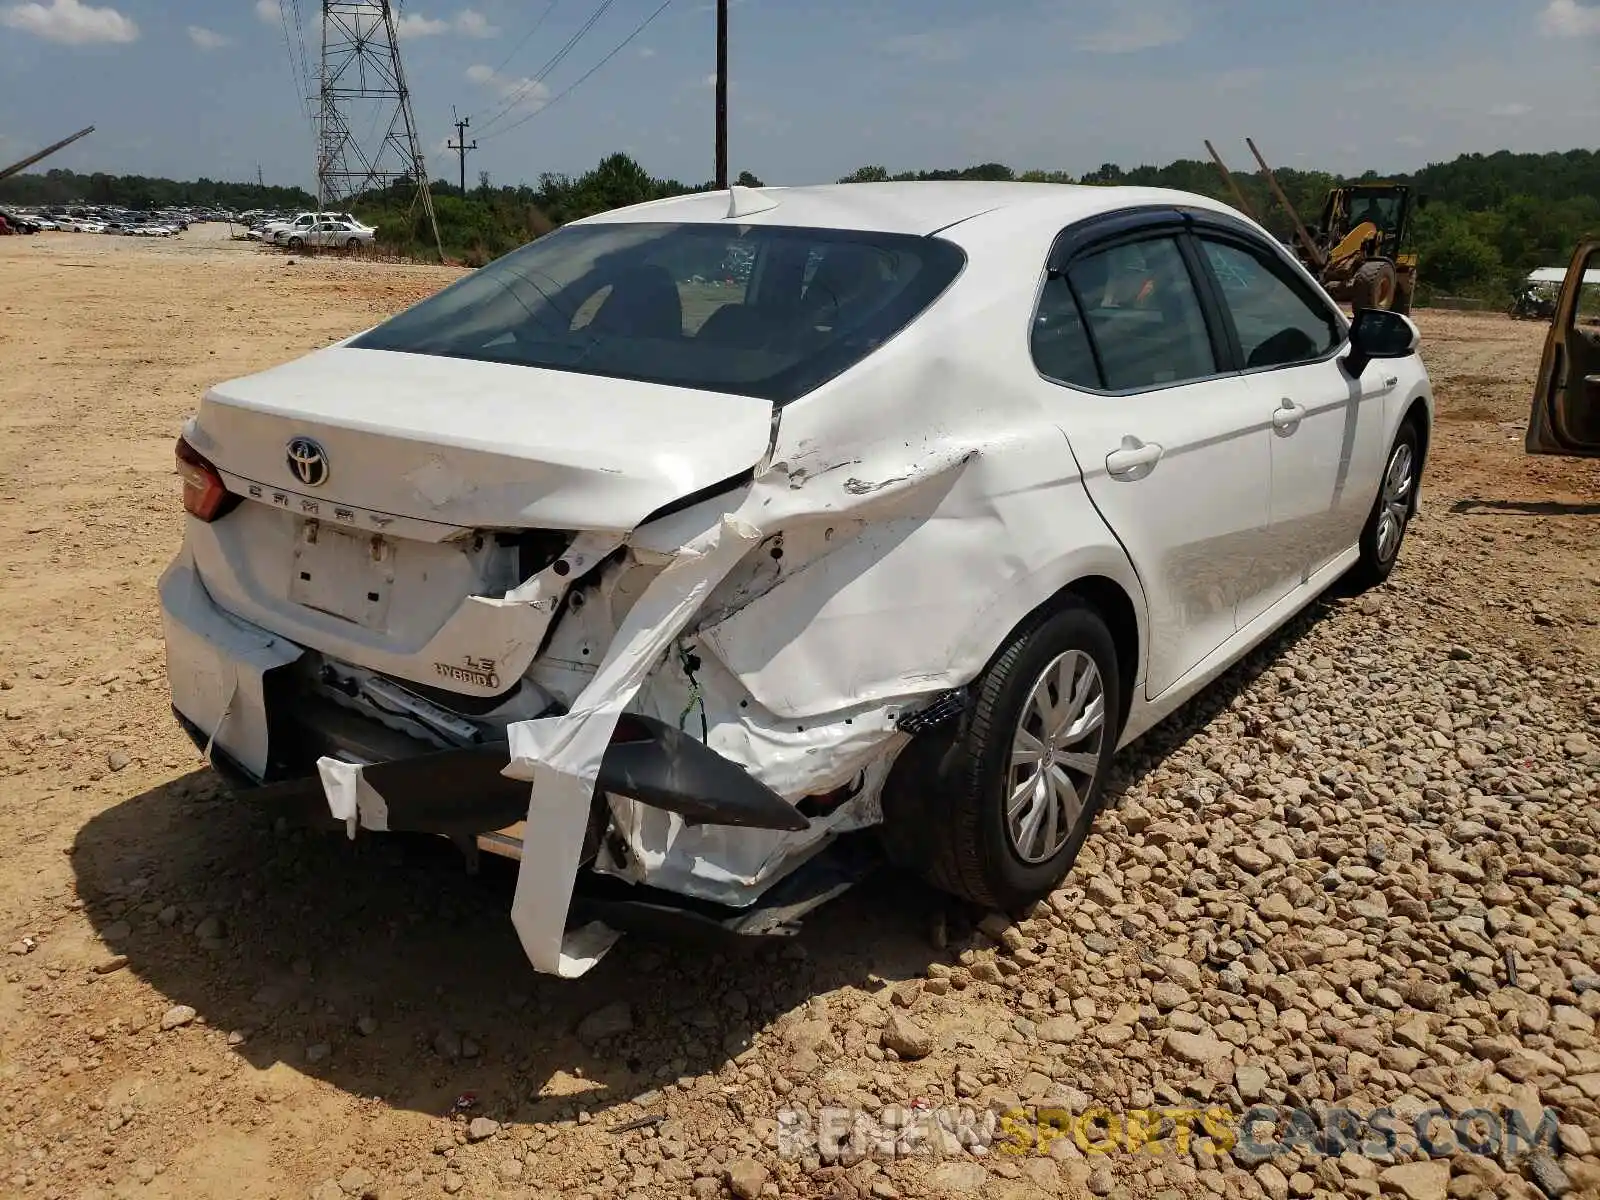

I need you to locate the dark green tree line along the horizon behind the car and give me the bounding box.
[0,150,1600,299]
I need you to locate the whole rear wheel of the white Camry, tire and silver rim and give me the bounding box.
[890,600,1122,910]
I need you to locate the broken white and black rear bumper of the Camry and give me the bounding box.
[160,555,810,835]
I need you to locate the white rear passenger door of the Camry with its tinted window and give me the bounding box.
[1032,213,1272,698]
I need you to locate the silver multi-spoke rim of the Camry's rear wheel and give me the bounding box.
[1005,650,1106,866]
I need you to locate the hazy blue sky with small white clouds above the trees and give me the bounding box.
[0,0,1600,184]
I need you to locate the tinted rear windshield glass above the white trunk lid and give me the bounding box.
[352,224,965,403]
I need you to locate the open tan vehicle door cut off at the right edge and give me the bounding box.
[1525,242,1600,458]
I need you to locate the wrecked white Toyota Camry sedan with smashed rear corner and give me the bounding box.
[160,182,1432,976]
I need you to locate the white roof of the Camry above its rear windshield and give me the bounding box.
[573,181,1232,237]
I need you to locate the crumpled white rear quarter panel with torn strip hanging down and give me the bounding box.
[507,334,1138,971]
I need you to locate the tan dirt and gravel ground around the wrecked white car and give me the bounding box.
[0,235,1600,1200]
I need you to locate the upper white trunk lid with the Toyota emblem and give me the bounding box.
[187,346,773,531]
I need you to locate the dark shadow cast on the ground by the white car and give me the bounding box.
[72,598,1336,1122]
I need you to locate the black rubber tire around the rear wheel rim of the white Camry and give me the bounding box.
[908,600,1122,912]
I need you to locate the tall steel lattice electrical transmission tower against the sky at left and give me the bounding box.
[317,0,445,258]
